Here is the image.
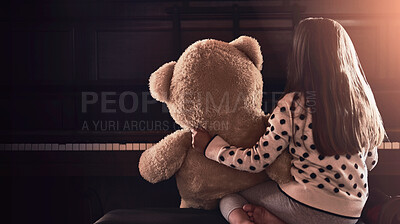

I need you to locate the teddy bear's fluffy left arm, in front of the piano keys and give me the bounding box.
[139,130,192,183]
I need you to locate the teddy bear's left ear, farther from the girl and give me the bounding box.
[149,61,176,102]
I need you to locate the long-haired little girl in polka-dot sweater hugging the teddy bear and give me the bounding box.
[192,18,385,224]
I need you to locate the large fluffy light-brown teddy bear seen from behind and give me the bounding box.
[139,36,291,210]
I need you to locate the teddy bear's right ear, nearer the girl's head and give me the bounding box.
[229,36,263,71]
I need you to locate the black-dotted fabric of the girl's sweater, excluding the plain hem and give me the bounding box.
[206,92,378,208]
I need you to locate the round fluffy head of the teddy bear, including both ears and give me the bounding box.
[149,36,263,134]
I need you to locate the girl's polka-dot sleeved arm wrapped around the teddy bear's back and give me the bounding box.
[194,96,292,173]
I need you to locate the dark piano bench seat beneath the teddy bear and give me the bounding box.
[94,208,228,224]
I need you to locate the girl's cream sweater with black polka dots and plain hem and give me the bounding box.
[205,93,378,218]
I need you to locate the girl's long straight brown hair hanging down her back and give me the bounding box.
[285,18,386,156]
